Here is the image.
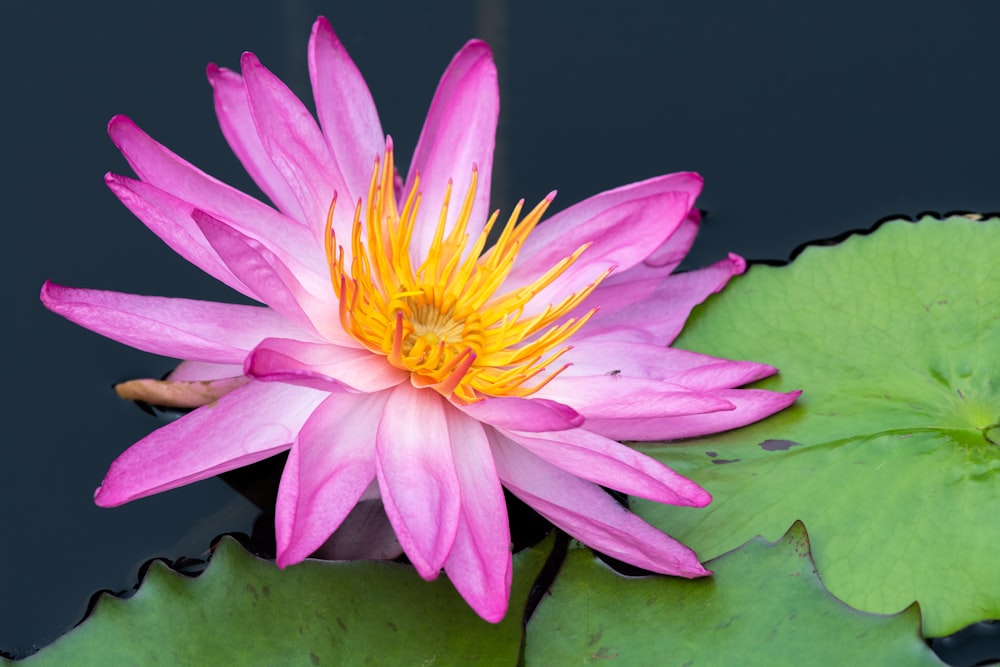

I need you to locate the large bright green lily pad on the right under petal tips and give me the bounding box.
[634,217,1000,636]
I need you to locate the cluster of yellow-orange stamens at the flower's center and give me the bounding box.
[326,146,611,403]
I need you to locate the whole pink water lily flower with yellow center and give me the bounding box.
[41,18,795,621]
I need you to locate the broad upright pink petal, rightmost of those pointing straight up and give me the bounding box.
[406,40,500,261]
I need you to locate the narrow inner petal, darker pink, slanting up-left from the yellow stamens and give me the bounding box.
[193,211,349,342]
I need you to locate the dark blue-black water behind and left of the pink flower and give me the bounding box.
[0,0,1000,653]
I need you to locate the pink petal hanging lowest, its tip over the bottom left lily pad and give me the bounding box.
[444,410,512,623]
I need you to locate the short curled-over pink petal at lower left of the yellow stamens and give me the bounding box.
[245,338,409,393]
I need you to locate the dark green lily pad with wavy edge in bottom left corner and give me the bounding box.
[24,537,553,667]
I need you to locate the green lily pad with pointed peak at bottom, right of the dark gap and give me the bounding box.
[525,523,943,667]
